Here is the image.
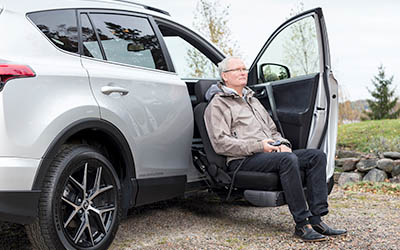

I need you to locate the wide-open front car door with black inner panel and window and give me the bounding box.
[249,8,338,178]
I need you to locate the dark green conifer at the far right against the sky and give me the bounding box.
[364,65,400,120]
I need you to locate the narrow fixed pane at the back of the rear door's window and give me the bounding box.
[81,14,103,59]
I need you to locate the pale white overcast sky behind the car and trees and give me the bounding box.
[138,0,400,101]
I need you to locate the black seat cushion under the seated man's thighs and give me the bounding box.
[229,171,305,191]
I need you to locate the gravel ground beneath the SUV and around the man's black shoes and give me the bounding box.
[0,187,400,249]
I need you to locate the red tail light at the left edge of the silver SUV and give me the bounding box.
[0,64,36,91]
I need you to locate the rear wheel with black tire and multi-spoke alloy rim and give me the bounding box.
[26,145,121,250]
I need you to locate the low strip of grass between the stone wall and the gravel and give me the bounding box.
[343,181,400,196]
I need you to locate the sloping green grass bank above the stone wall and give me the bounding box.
[337,119,400,153]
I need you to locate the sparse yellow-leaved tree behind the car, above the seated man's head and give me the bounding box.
[186,0,240,77]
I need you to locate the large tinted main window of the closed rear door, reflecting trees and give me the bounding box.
[90,14,167,70]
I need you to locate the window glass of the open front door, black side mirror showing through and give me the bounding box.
[257,16,320,82]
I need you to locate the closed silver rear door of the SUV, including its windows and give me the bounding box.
[79,10,193,204]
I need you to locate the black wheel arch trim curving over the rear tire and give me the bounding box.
[32,118,137,200]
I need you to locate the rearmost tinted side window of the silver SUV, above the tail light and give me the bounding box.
[28,10,78,53]
